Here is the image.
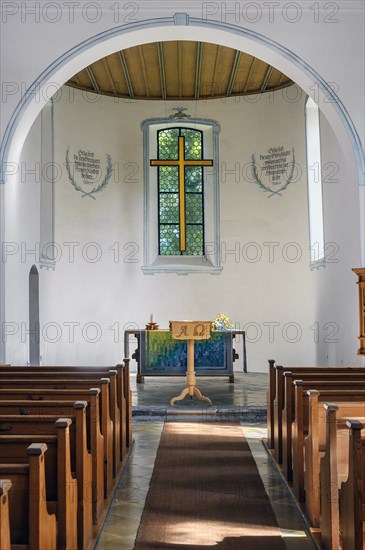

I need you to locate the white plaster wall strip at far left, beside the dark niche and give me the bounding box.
[2,116,42,365]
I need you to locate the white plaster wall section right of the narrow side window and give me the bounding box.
[311,115,363,365]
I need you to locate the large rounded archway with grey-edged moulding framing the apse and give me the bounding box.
[0,14,365,183]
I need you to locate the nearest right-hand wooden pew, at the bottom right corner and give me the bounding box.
[339,420,365,550]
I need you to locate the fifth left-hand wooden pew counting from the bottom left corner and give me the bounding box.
[0,388,107,524]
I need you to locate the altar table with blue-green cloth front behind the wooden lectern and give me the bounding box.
[124,329,247,383]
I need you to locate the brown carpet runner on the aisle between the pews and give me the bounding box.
[134,422,286,550]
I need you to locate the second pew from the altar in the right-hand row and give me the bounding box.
[274,370,365,470]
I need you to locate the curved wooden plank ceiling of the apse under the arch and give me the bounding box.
[66,41,293,100]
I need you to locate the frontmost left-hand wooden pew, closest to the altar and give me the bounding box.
[0,359,132,460]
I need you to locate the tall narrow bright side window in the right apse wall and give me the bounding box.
[305,97,325,267]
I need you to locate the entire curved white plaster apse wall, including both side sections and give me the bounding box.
[6,81,361,371]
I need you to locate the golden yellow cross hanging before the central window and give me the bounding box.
[150,136,213,252]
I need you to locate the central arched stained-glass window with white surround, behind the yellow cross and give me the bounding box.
[142,118,221,273]
